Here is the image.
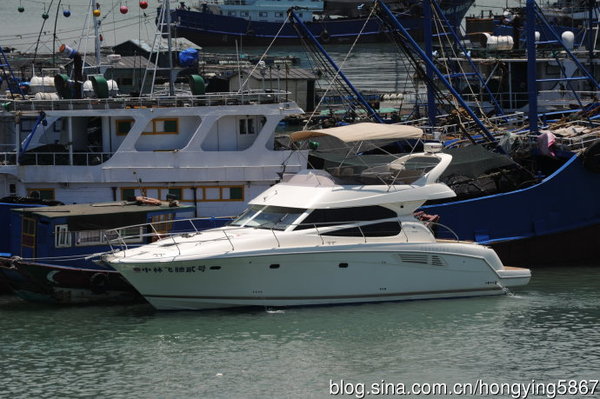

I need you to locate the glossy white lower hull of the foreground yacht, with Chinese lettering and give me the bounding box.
[111,244,530,310]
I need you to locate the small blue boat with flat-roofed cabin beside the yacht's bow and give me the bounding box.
[0,202,230,304]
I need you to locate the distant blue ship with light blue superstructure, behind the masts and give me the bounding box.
[165,0,474,47]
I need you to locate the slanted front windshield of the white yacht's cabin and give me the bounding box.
[231,205,306,230]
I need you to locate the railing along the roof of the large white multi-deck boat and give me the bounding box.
[8,90,290,111]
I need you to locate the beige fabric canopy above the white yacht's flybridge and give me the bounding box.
[290,122,423,143]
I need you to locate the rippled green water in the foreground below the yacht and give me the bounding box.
[0,267,600,398]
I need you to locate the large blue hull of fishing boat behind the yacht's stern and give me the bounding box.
[422,155,600,265]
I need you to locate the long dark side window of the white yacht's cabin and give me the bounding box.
[296,206,397,230]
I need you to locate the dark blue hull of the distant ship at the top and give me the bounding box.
[172,0,474,47]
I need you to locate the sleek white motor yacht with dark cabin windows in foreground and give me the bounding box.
[102,139,531,310]
